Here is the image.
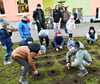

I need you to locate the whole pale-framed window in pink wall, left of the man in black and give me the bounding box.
[17,0,29,13]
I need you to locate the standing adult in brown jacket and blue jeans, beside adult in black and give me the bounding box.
[62,7,70,36]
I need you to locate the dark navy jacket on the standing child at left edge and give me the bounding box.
[0,29,13,49]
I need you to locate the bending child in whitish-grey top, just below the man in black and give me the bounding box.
[39,29,49,48]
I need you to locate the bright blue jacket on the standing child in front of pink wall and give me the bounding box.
[18,21,31,38]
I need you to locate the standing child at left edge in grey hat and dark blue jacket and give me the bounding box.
[0,18,13,65]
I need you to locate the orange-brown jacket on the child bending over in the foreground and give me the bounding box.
[12,46,36,71]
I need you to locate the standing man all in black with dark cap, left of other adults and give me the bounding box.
[33,4,46,33]
